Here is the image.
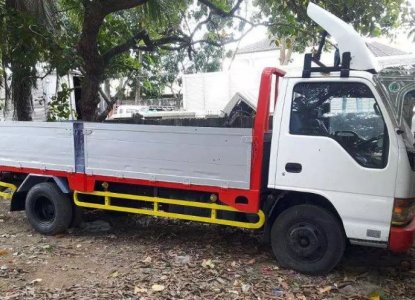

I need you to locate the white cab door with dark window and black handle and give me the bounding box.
[269,78,398,242]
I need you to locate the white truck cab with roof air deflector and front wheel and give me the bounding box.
[268,3,415,271]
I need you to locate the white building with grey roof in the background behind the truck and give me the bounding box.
[183,39,415,116]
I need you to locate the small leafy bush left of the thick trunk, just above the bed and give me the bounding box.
[48,83,73,121]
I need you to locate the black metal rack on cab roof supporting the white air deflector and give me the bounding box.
[303,31,351,78]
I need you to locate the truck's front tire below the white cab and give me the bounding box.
[271,204,346,275]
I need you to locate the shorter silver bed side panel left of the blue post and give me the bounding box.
[0,122,74,172]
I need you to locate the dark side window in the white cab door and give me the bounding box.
[290,82,389,169]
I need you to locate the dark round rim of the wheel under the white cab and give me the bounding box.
[287,222,327,262]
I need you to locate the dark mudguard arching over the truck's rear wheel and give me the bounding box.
[10,174,71,211]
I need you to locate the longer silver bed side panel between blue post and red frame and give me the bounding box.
[84,123,252,189]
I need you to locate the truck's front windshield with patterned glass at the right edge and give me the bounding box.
[375,66,415,148]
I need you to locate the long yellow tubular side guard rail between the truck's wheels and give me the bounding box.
[73,191,265,229]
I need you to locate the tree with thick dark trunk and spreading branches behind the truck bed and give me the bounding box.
[64,0,250,121]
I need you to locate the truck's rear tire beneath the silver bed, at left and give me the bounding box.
[26,182,73,235]
